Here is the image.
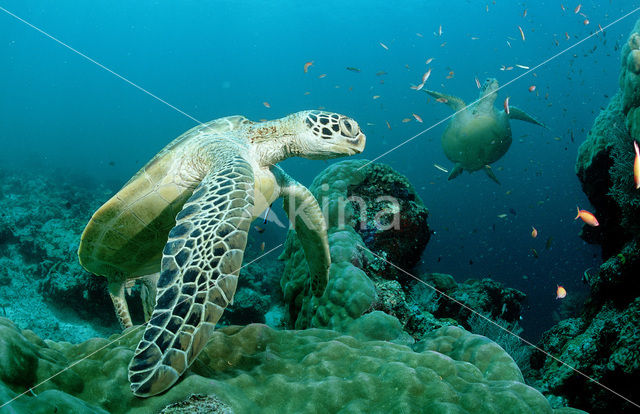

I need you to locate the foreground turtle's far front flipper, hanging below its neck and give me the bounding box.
[272,166,331,297]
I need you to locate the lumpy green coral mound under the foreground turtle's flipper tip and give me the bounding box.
[0,312,582,414]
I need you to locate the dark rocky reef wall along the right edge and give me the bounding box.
[531,17,640,413]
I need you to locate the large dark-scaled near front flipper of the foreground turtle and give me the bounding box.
[129,151,254,397]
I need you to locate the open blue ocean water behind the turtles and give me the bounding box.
[0,0,638,338]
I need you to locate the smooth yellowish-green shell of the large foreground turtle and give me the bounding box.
[78,115,251,282]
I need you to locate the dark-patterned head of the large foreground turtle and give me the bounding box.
[291,111,366,160]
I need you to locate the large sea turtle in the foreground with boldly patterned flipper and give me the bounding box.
[78,111,366,397]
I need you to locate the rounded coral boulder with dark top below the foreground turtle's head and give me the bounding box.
[280,160,430,330]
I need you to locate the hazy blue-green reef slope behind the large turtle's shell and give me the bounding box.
[0,171,118,342]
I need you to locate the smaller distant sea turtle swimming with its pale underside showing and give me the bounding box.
[423,78,544,184]
